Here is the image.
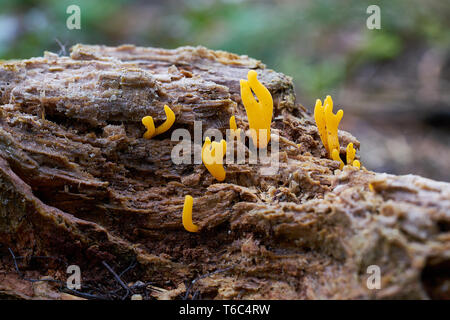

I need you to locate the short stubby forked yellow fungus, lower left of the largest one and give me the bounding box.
[202,137,227,181]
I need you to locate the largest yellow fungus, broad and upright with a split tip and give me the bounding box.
[240,70,273,148]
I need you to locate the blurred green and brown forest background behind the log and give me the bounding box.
[0,0,450,181]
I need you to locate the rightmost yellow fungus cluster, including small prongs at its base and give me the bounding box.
[314,96,361,170]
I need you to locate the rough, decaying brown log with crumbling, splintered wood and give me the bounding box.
[0,45,450,299]
